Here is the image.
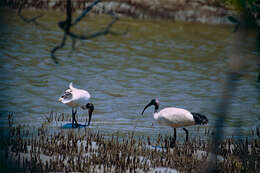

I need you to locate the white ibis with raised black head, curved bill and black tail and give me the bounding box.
[142,99,208,141]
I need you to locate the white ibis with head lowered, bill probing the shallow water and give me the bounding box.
[59,82,94,128]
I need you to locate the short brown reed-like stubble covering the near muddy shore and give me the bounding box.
[0,115,260,172]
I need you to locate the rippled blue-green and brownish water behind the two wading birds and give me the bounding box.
[0,10,260,139]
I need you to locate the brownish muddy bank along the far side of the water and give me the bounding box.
[1,0,234,24]
